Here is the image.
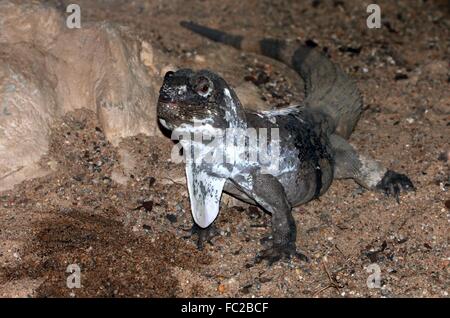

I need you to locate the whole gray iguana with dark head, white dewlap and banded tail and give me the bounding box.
[158,22,414,264]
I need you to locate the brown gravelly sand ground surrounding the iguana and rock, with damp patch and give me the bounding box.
[0,0,450,297]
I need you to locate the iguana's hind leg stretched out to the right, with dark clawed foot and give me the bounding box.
[330,135,415,202]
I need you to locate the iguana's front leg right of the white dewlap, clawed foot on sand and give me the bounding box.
[237,172,308,265]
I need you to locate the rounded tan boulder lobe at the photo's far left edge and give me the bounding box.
[0,44,57,191]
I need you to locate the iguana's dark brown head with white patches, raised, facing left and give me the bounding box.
[158,69,244,130]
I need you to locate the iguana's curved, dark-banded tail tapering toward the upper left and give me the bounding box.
[181,21,362,138]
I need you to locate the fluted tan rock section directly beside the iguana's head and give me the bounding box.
[45,23,159,145]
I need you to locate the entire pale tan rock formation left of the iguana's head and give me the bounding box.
[0,1,166,191]
